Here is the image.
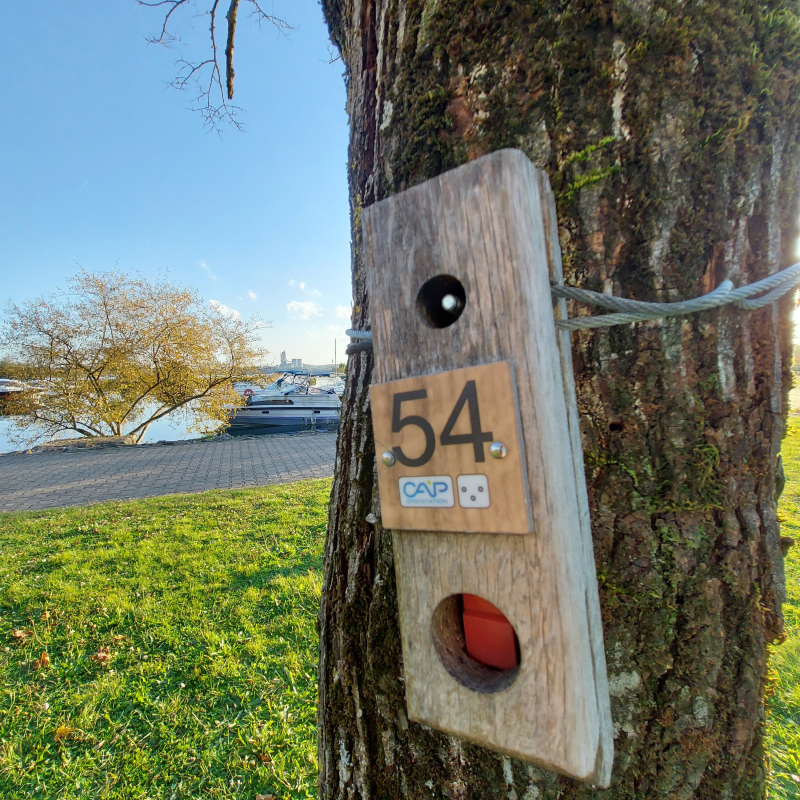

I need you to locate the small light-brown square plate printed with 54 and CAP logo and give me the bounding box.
[370,361,532,533]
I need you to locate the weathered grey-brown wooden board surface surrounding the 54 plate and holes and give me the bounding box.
[363,150,612,785]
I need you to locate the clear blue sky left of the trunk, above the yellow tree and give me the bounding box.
[0,0,350,363]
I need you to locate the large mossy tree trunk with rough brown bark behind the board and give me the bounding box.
[319,0,800,800]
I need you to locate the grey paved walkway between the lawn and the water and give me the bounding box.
[0,433,336,511]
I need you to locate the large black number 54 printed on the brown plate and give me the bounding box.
[392,381,494,467]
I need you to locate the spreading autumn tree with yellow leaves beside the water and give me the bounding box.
[0,271,266,442]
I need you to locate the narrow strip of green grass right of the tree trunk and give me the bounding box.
[767,417,800,800]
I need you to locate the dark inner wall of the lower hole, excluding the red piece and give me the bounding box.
[431,594,520,694]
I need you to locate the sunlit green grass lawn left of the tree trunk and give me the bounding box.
[0,481,330,800]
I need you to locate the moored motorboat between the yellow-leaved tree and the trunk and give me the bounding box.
[230,371,342,433]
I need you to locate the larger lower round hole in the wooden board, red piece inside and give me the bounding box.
[431,594,520,694]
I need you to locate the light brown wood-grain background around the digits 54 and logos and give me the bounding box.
[370,361,531,533]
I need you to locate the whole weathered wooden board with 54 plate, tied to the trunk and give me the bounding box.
[361,150,614,786]
